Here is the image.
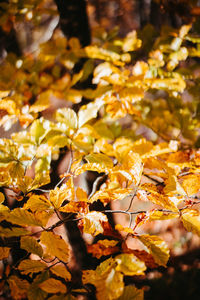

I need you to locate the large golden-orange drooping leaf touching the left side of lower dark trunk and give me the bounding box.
[40,231,69,262]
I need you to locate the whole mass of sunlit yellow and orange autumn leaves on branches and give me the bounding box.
[0,3,200,300]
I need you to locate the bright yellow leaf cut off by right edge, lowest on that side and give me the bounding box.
[181,209,200,236]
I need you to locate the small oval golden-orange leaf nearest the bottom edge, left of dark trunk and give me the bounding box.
[39,278,67,294]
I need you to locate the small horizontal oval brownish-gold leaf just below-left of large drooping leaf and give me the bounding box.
[18,259,47,275]
